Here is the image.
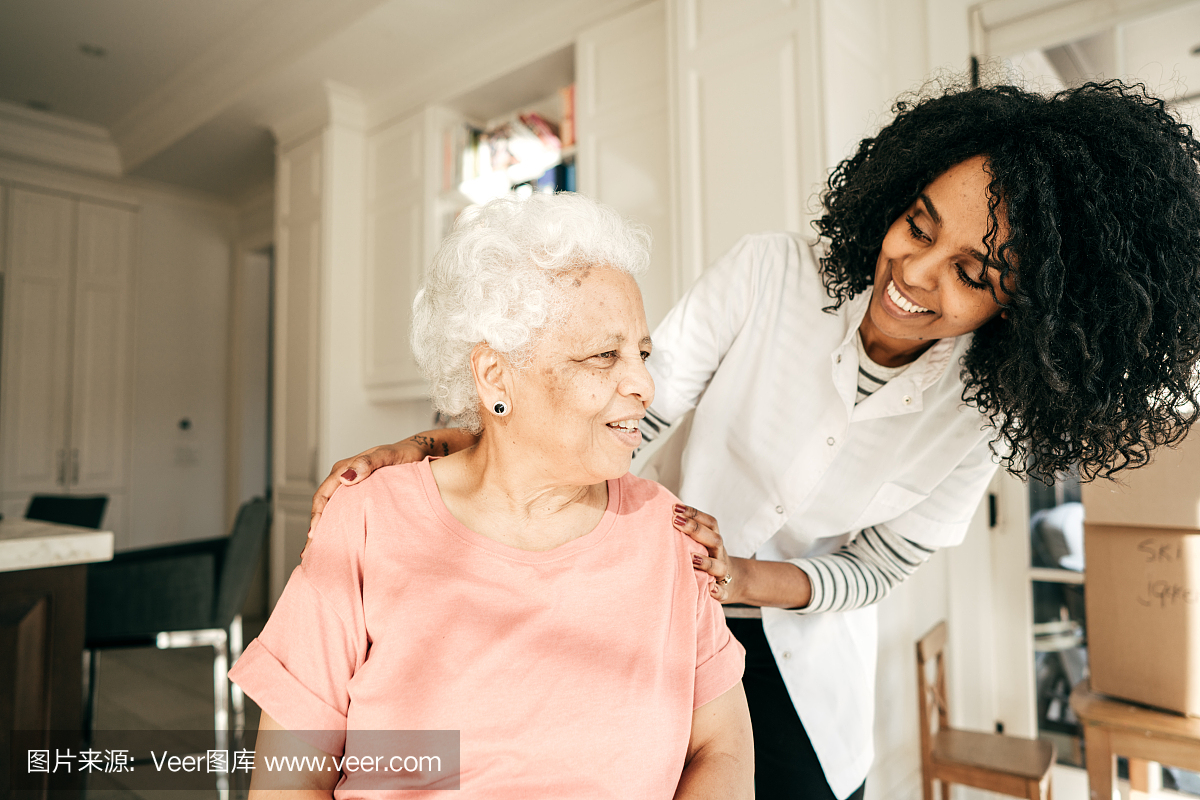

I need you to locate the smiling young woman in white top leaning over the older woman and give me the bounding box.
[313,82,1200,800]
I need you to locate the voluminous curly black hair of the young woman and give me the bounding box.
[814,80,1200,481]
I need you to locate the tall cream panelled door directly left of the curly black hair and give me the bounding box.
[667,0,824,288]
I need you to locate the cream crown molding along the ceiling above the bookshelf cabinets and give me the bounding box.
[367,0,647,130]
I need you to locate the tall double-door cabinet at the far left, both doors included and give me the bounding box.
[0,187,136,543]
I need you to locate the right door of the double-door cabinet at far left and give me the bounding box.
[67,200,134,493]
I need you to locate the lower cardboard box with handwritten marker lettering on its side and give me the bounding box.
[1084,522,1200,716]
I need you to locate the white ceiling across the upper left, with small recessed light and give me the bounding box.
[0,0,644,200]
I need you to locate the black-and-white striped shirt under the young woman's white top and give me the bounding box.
[641,335,936,616]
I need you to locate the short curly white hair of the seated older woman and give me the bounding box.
[412,192,650,433]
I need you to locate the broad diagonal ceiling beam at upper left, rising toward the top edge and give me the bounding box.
[112,0,385,169]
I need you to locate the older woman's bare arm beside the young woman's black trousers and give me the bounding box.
[674,681,754,800]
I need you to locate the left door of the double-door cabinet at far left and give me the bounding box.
[0,190,76,493]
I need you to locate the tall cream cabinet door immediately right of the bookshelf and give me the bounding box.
[575,0,682,330]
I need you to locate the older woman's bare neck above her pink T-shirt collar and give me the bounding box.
[433,435,608,551]
